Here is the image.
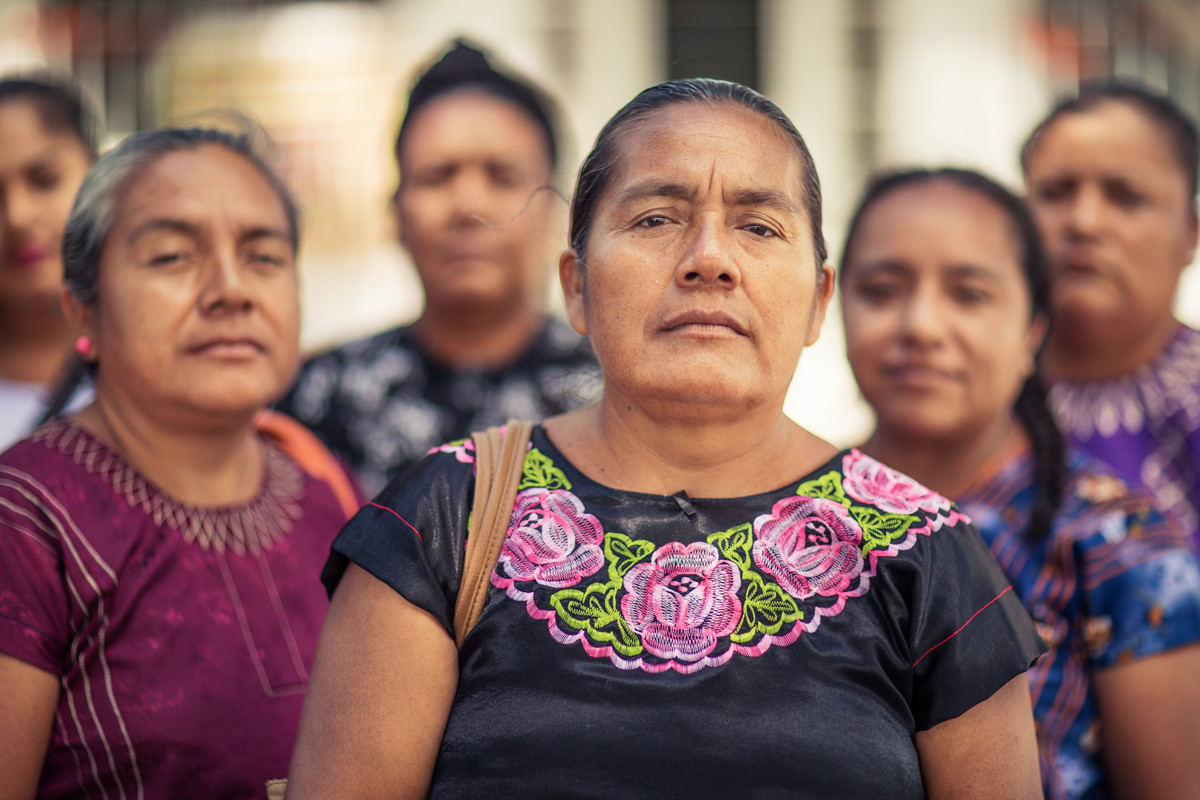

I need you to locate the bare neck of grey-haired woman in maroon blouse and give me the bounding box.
[76,393,263,507]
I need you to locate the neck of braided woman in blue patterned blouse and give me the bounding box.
[860,416,1026,500]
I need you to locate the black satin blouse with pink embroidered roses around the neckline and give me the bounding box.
[323,427,1043,800]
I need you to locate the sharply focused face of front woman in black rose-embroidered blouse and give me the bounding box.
[559,103,833,413]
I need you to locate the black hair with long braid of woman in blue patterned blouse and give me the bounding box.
[838,168,1067,541]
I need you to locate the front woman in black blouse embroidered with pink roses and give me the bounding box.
[288,79,1040,800]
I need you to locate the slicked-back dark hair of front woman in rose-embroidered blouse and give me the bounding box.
[571,78,828,279]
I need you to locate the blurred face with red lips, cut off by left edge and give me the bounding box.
[0,100,91,313]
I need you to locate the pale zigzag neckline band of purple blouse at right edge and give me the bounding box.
[1050,325,1200,439]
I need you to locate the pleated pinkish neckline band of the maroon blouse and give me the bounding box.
[30,420,304,555]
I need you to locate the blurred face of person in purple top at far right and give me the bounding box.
[1026,101,1196,351]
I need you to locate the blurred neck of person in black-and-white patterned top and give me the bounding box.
[413,307,546,368]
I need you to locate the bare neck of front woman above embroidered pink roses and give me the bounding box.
[546,390,836,498]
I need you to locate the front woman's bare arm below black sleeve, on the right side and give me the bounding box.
[917,673,1042,800]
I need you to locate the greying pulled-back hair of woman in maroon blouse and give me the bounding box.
[62,127,300,303]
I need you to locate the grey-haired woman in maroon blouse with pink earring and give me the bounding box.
[0,130,354,799]
